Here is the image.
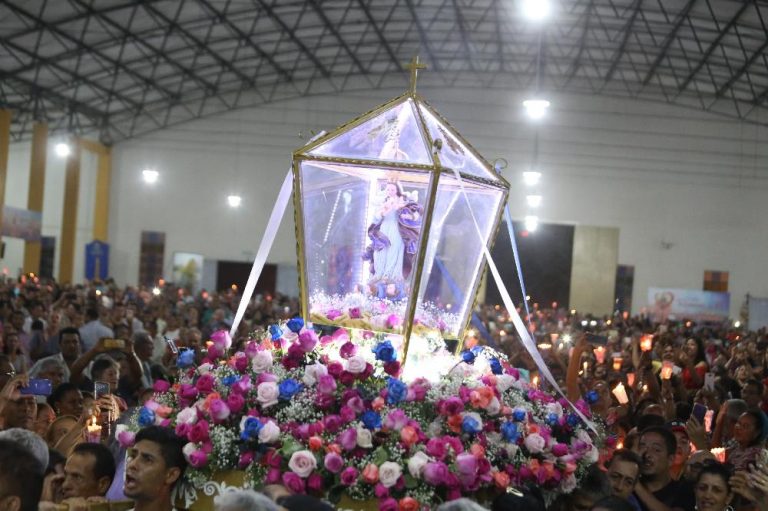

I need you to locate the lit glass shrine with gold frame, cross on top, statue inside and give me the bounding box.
[293,59,509,360]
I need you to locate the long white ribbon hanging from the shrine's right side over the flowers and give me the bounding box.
[453,169,597,434]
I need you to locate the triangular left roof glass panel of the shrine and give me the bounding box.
[309,99,432,165]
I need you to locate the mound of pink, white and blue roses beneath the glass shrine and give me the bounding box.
[123,319,601,511]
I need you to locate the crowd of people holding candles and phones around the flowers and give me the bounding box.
[0,276,768,511]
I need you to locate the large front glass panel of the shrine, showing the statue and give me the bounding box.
[300,161,430,333]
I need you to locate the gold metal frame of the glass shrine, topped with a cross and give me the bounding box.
[292,58,510,359]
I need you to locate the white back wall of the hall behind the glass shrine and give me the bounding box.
[8,89,768,316]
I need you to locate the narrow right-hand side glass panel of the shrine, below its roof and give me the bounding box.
[415,174,504,339]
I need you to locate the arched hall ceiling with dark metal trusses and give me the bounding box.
[0,0,768,144]
